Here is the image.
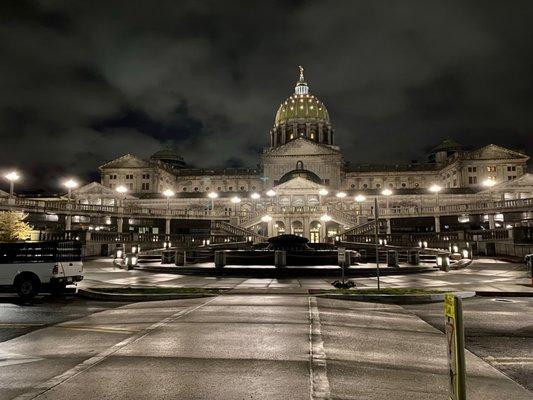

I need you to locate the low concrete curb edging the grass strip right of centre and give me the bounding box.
[317,292,476,304]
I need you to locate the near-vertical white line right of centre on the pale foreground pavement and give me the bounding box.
[309,296,331,400]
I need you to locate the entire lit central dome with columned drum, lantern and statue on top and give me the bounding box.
[270,67,333,147]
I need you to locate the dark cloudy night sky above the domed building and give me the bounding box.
[0,0,533,189]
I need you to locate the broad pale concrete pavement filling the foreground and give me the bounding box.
[0,294,532,400]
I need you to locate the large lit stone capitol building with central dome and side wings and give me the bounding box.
[58,67,533,242]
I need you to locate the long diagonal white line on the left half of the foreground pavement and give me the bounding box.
[13,297,216,400]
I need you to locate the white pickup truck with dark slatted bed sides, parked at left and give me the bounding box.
[0,241,83,299]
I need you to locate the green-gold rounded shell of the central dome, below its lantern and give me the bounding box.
[274,93,329,125]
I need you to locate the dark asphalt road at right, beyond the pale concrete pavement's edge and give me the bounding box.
[404,297,533,391]
